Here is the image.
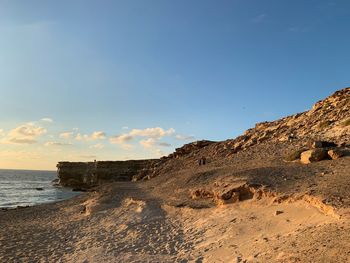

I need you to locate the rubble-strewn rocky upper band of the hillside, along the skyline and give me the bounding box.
[134,88,350,183]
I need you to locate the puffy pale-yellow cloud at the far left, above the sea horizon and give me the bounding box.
[2,122,47,144]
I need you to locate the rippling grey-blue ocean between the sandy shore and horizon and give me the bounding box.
[0,169,79,208]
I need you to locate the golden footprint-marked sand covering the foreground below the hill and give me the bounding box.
[0,177,350,262]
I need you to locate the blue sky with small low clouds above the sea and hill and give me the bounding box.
[0,0,350,170]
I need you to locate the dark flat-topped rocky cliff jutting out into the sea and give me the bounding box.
[57,159,156,188]
